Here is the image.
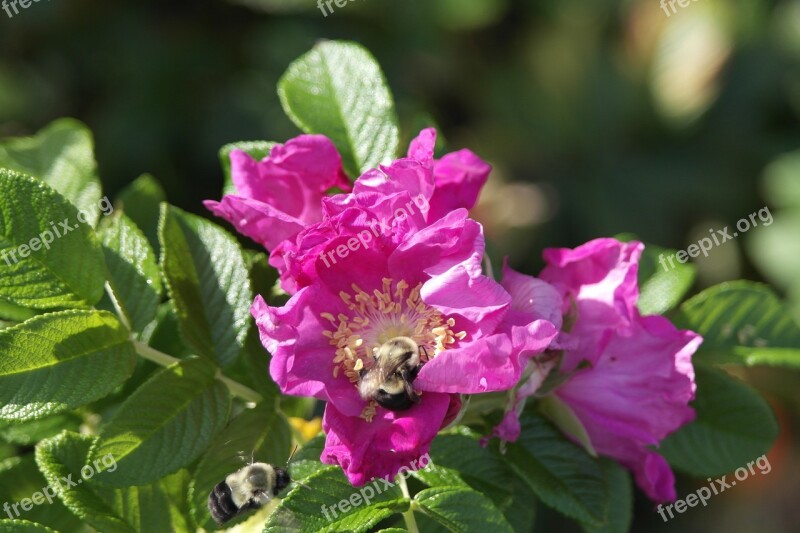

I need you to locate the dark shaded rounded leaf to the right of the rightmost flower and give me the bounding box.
[659,367,778,477]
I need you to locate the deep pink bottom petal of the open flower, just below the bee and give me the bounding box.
[320,392,453,486]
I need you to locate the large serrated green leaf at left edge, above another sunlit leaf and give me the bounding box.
[0,169,105,309]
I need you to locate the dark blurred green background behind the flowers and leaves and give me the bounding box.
[0,0,800,532]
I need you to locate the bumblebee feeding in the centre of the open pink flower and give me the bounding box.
[358,337,424,411]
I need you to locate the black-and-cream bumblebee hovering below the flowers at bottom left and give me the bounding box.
[208,463,291,525]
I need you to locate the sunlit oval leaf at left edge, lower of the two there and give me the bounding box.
[0,311,136,421]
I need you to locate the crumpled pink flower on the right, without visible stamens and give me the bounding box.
[495,239,702,502]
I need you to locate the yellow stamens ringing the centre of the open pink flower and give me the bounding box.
[320,278,467,414]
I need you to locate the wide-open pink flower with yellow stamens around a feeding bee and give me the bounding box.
[252,184,560,485]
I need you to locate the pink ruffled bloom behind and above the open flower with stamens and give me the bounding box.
[205,129,491,294]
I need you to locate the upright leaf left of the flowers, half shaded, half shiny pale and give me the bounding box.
[159,204,253,367]
